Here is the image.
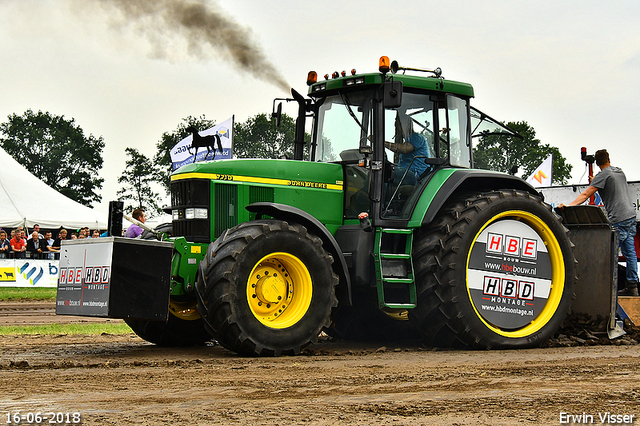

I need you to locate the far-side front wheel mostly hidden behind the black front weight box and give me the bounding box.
[125,223,212,346]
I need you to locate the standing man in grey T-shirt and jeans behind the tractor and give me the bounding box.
[560,149,638,296]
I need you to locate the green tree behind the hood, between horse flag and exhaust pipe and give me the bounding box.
[233,114,311,158]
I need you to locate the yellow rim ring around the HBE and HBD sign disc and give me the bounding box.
[466,210,565,338]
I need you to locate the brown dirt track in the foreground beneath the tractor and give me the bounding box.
[0,302,640,425]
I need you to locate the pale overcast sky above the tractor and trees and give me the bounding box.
[0,0,640,212]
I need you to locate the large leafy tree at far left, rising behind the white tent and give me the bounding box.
[0,109,104,206]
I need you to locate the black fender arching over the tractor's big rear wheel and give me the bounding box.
[422,169,544,226]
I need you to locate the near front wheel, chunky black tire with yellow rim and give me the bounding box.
[196,220,338,356]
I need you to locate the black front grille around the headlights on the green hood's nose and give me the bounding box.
[171,179,211,243]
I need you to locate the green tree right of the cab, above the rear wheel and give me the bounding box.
[473,121,573,185]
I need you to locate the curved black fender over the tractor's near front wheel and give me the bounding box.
[246,202,352,306]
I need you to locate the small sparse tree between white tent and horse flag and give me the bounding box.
[117,148,162,217]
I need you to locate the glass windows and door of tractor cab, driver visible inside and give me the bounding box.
[312,88,471,220]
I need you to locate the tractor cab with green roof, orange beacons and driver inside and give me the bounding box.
[298,57,473,225]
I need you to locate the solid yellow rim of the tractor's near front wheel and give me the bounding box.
[247,252,313,329]
